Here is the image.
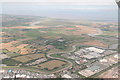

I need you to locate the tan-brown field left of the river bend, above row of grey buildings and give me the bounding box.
[12,54,45,63]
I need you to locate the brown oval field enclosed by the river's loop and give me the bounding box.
[37,60,66,70]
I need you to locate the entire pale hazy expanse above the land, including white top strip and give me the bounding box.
[0,0,118,20]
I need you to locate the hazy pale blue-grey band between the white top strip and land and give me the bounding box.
[0,3,118,21]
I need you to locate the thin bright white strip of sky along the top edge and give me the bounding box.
[0,0,115,5]
